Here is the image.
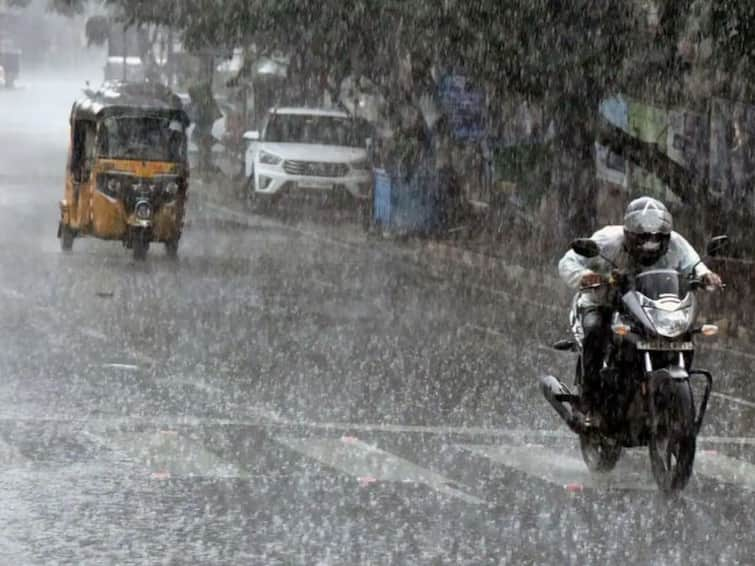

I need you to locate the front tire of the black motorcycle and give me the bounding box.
[649,378,697,494]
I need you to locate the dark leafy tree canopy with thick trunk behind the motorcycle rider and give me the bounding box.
[39,0,755,253]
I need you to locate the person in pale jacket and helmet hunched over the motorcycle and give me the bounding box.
[558,196,723,415]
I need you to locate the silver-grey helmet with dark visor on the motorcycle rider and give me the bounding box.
[624,197,673,265]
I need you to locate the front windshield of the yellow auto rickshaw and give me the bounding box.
[98,116,186,162]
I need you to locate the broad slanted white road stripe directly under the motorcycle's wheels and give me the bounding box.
[457,444,658,491]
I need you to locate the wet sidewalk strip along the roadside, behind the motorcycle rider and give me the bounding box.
[190,174,755,350]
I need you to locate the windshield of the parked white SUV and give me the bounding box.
[265,114,363,147]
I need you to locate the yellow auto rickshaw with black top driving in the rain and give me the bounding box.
[58,83,189,259]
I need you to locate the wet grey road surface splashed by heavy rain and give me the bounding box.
[0,73,755,565]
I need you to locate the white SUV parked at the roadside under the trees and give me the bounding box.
[244,108,372,204]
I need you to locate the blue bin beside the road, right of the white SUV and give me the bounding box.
[373,169,440,234]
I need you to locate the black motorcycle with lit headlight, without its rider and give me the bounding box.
[540,236,727,494]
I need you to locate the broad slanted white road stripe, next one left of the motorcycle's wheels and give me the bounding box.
[276,437,484,505]
